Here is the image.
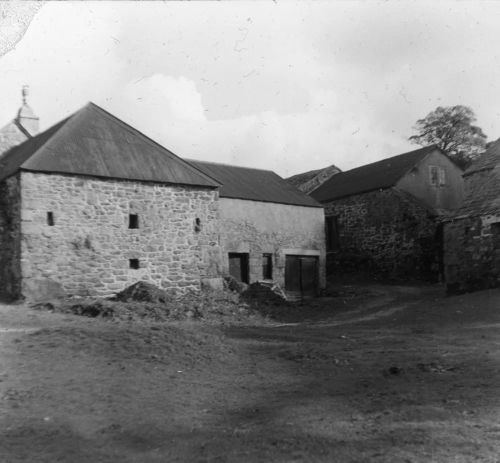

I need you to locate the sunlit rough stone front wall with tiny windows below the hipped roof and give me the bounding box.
[21,172,220,297]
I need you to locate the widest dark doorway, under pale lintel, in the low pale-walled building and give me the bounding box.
[285,255,318,297]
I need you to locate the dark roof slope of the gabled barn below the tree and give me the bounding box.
[310,145,438,202]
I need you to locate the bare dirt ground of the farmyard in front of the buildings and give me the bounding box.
[0,286,500,463]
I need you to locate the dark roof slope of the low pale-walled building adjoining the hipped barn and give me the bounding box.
[190,160,321,207]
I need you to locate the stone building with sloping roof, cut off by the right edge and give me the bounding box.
[444,139,500,293]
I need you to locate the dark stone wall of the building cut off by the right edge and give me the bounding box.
[444,216,500,294]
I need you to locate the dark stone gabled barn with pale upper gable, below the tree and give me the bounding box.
[310,146,463,281]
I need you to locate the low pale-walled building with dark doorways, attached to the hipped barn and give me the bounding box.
[191,161,325,297]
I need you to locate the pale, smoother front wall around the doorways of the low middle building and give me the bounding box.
[220,198,326,288]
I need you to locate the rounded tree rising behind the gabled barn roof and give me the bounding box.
[409,105,487,167]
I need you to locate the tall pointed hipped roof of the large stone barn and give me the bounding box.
[0,103,218,188]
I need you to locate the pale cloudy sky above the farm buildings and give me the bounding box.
[0,0,500,177]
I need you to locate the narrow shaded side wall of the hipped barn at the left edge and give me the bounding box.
[0,176,21,300]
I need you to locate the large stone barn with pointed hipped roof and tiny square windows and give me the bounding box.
[0,103,221,299]
